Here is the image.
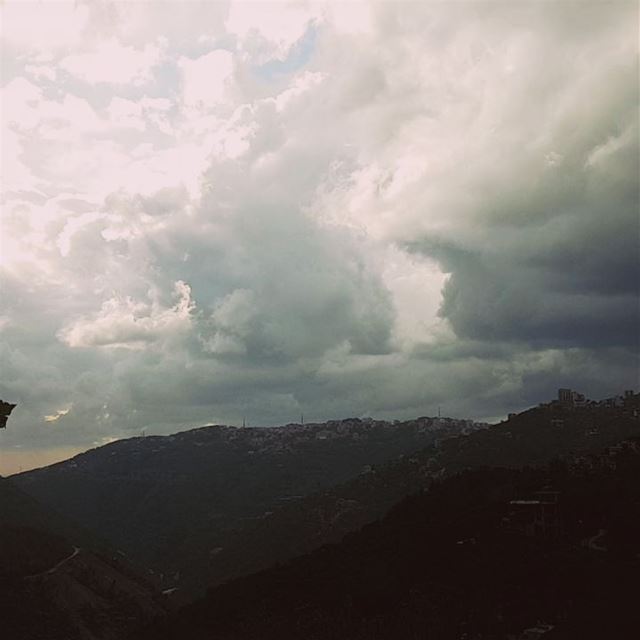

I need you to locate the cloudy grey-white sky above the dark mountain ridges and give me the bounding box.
[0,0,640,473]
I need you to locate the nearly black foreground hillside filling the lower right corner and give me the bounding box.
[137,441,640,640]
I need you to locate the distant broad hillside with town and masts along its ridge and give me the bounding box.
[13,418,483,587]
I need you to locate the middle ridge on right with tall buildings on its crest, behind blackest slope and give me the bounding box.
[198,395,640,585]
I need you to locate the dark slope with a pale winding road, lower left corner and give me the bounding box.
[0,478,165,640]
